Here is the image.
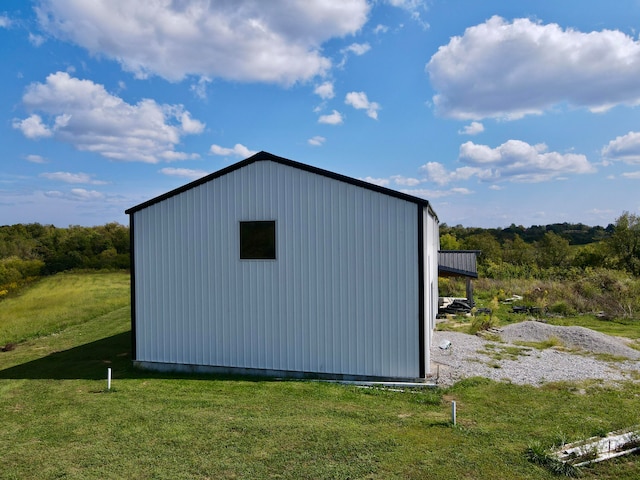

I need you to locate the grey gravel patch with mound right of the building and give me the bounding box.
[431,322,640,385]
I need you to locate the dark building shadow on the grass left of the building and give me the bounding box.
[0,332,134,380]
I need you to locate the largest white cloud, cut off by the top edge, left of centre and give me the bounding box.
[37,0,371,85]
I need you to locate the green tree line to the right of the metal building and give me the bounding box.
[440,212,640,278]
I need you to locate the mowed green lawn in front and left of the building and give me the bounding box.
[0,272,640,480]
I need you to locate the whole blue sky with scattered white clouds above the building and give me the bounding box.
[0,0,640,228]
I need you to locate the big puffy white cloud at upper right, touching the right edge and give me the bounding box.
[426,16,640,119]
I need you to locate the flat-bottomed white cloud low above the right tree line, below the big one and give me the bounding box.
[421,140,595,185]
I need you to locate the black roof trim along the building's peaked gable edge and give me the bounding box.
[124,152,438,220]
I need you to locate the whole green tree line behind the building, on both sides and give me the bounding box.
[0,212,640,296]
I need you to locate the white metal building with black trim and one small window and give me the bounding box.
[126,152,439,380]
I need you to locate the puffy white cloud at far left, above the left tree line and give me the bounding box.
[13,72,204,163]
